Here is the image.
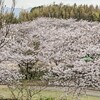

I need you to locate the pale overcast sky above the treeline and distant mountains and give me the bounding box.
[5,0,100,8]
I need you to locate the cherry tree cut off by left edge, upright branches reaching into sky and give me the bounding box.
[0,0,21,84]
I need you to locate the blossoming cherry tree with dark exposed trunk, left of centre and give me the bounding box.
[6,30,45,80]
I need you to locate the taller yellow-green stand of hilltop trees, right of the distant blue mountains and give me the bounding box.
[27,3,100,21]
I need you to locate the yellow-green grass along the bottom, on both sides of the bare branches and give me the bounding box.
[0,85,100,100]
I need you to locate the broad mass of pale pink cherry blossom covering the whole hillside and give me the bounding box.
[0,18,100,88]
